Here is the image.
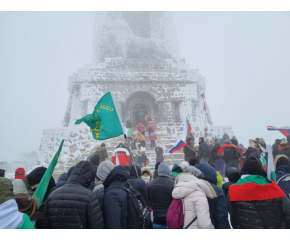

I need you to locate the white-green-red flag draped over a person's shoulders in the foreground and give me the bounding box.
[229,175,286,201]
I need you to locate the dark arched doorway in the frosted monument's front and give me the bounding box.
[124,91,158,125]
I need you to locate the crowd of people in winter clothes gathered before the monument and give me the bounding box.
[0,134,290,229]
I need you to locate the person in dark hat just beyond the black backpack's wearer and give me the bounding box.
[127,165,147,201]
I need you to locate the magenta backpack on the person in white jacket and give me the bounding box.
[166,199,197,229]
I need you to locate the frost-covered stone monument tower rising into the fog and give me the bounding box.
[39,11,232,172]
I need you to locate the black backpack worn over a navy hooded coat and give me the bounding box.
[106,185,152,229]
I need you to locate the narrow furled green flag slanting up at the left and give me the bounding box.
[32,140,64,208]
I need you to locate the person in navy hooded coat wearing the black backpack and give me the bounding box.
[103,165,130,229]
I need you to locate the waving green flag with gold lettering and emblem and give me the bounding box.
[75,92,124,140]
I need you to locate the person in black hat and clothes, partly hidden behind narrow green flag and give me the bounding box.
[26,167,56,229]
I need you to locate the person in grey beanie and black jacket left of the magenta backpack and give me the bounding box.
[147,163,174,229]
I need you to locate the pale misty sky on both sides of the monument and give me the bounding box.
[0,12,290,161]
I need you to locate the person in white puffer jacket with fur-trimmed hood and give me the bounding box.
[172,173,217,229]
